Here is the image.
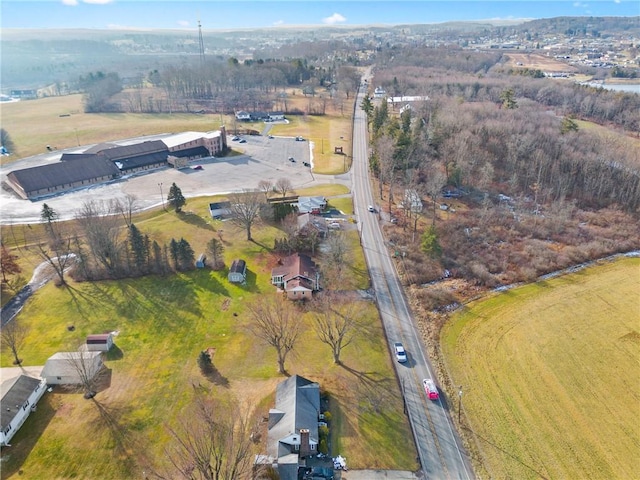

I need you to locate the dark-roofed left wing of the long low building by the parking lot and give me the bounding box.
[7,155,120,199]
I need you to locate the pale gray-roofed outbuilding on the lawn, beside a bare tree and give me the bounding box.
[41,352,103,385]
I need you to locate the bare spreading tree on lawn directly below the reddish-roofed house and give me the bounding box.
[248,297,300,375]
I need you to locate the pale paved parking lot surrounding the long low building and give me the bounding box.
[0,130,350,224]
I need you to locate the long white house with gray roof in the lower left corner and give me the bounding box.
[0,375,47,446]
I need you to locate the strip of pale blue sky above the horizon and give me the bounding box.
[0,0,640,30]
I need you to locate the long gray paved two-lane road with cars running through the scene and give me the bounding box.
[352,82,475,480]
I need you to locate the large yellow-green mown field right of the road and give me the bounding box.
[441,258,640,479]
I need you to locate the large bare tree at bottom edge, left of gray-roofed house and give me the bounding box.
[158,393,253,480]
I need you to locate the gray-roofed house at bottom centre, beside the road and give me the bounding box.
[267,375,320,480]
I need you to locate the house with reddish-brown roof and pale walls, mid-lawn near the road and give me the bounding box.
[271,253,320,300]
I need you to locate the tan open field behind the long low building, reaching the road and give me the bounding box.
[0,87,352,169]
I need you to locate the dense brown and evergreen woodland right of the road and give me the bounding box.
[363,48,640,290]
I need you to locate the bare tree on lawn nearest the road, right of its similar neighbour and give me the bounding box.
[313,294,356,364]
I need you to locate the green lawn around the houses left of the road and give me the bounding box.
[0,197,417,480]
